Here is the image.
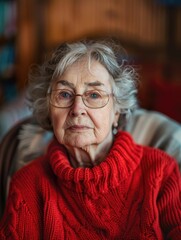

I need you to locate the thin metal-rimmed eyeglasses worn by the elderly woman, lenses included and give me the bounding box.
[48,89,113,109]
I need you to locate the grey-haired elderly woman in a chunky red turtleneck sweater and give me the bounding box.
[0,41,181,240]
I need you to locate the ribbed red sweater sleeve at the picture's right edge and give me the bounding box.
[158,158,181,240]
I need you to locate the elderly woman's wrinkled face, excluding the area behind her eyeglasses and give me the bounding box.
[50,59,118,148]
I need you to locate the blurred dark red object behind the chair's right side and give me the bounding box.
[150,79,181,123]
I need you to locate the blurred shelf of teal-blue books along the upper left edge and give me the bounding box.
[0,0,17,105]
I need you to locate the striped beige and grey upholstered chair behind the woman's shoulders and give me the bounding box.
[0,109,181,218]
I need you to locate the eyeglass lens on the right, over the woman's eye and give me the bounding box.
[83,90,109,108]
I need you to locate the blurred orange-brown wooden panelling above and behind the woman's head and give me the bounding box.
[17,0,181,89]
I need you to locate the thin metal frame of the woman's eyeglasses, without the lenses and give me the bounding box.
[47,89,114,109]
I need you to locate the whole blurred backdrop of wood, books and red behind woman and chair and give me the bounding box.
[0,0,181,139]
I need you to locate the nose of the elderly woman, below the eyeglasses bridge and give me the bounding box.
[70,95,86,117]
